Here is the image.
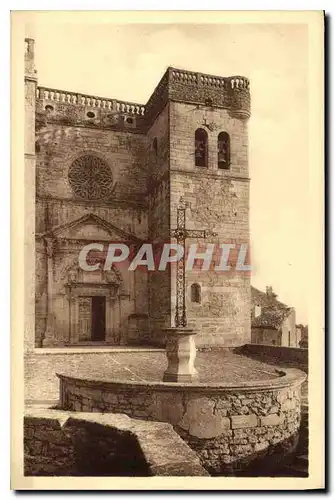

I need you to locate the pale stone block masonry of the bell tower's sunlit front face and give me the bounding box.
[169,102,250,346]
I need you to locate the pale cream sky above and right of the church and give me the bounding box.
[26,15,310,323]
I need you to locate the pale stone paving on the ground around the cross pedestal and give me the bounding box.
[25,350,279,402]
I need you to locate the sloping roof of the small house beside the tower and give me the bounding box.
[251,286,293,330]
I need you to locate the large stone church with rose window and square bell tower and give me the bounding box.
[25,39,250,348]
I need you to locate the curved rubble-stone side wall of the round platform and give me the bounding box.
[60,369,305,475]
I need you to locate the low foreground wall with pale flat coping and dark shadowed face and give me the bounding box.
[24,410,208,476]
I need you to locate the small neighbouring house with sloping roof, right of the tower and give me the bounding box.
[251,286,300,347]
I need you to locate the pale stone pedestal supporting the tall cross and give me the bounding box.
[163,328,198,382]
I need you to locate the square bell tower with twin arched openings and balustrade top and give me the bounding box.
[146,67,251,346]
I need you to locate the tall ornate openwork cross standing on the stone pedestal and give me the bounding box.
[171,208,217,328]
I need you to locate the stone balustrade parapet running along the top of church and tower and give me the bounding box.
[36,67,250,132]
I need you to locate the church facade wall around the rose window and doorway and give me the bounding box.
[35,121,148,347]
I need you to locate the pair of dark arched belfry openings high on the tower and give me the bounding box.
[194,128,230,169]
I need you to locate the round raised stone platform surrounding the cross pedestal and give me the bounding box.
[57,350,306,475]
